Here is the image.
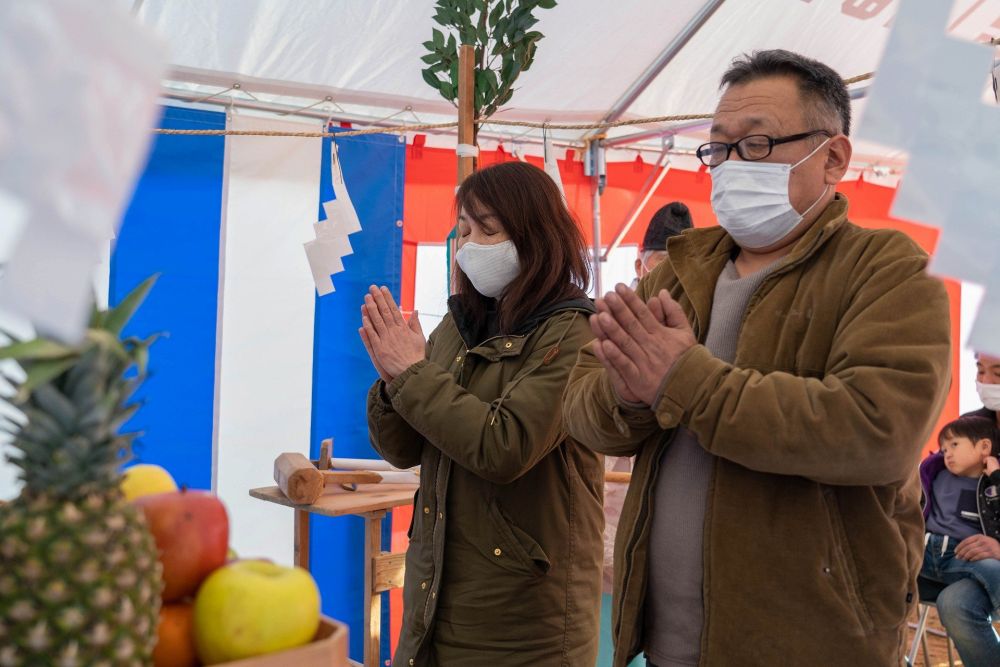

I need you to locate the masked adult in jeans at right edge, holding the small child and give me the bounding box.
[935,352,1000,667]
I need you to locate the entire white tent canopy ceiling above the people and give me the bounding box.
[139,0,1000,164]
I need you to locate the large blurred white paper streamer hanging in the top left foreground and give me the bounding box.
[0,0,166,342]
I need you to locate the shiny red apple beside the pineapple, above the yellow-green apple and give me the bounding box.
[133,490,229,602]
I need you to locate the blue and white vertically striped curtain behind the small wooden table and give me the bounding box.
[109,107,405,657]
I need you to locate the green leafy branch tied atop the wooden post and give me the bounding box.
[421,0,556,118]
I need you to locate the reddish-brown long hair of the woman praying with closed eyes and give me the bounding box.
[455,162,590,333]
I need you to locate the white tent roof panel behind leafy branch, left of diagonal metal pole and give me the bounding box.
[139,0,704,120]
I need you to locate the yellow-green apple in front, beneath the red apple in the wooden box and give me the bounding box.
[194,560,319,665]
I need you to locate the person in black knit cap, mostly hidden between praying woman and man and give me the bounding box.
[597,201,693,667]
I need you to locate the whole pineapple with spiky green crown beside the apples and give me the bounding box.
[0,276,162,667]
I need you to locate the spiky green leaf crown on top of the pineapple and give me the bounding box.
[0,276,159,497]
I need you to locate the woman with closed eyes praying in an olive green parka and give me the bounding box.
[360,162,604,667]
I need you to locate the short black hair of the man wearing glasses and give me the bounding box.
[719,49,851,135]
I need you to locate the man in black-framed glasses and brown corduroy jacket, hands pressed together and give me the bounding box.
[563,50,951,667]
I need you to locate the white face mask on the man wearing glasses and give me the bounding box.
[711,139,830,250]
